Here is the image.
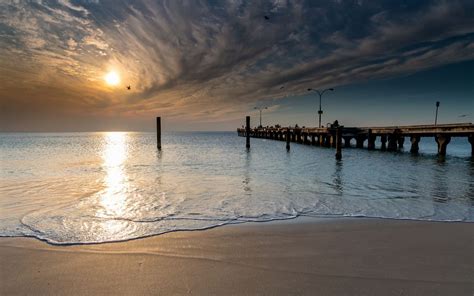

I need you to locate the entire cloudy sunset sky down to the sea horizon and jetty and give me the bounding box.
[0,0,474,131]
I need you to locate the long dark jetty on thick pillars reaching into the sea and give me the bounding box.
[237,122,474,158]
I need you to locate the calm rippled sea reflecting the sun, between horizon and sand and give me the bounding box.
[0,132,474,244]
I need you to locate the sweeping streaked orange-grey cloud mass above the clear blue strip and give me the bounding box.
[0,0,474,130]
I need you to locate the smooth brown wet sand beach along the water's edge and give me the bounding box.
[0,219,474,296]
